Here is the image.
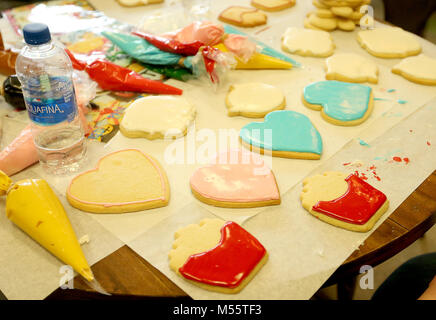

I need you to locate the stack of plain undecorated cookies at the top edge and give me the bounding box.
[304,0,371,31]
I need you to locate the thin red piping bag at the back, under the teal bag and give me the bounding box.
[132,31,204,56]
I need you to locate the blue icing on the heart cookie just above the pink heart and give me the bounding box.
[240,110,322,154]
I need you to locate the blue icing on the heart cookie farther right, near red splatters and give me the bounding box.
[304,81,371,121]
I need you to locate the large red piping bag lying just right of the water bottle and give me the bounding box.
[65,50,183,95]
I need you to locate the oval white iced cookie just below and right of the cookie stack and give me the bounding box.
[357,27,421,58]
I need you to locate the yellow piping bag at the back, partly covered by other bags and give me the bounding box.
[214,43,292,69]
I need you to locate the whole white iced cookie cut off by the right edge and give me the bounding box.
[392,54,436,85]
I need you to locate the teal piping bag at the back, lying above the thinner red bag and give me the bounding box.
[102,32,183,66]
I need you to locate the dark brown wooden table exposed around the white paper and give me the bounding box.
[47,171,436,299]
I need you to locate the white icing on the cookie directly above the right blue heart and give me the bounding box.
[326,53,378,79]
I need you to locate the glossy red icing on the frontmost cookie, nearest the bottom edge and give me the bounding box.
[179,221,266,288]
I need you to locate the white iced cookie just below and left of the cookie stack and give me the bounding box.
[282,27,335,57]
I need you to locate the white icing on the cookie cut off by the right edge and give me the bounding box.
[393,54,436,81]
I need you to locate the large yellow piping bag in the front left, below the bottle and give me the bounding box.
[0,170,94,281]
